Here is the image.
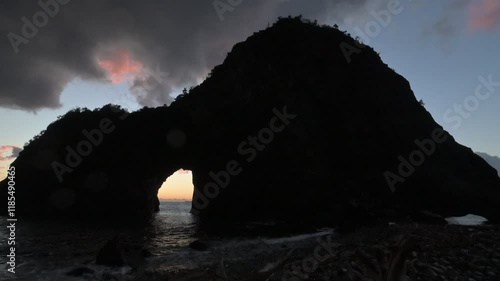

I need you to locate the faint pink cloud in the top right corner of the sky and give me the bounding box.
[467,0,500,31]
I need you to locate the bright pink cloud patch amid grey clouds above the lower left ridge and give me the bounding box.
[97,49,143,84]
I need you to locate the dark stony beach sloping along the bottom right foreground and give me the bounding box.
[45,222,500,281]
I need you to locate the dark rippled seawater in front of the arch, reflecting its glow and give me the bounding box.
[0,200,331,281]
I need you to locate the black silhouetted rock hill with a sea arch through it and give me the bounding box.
[2,18,500,222]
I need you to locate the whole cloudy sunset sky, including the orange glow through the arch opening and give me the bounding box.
[0,0,500,199]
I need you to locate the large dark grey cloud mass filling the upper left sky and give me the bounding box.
[0,0,373,111]
